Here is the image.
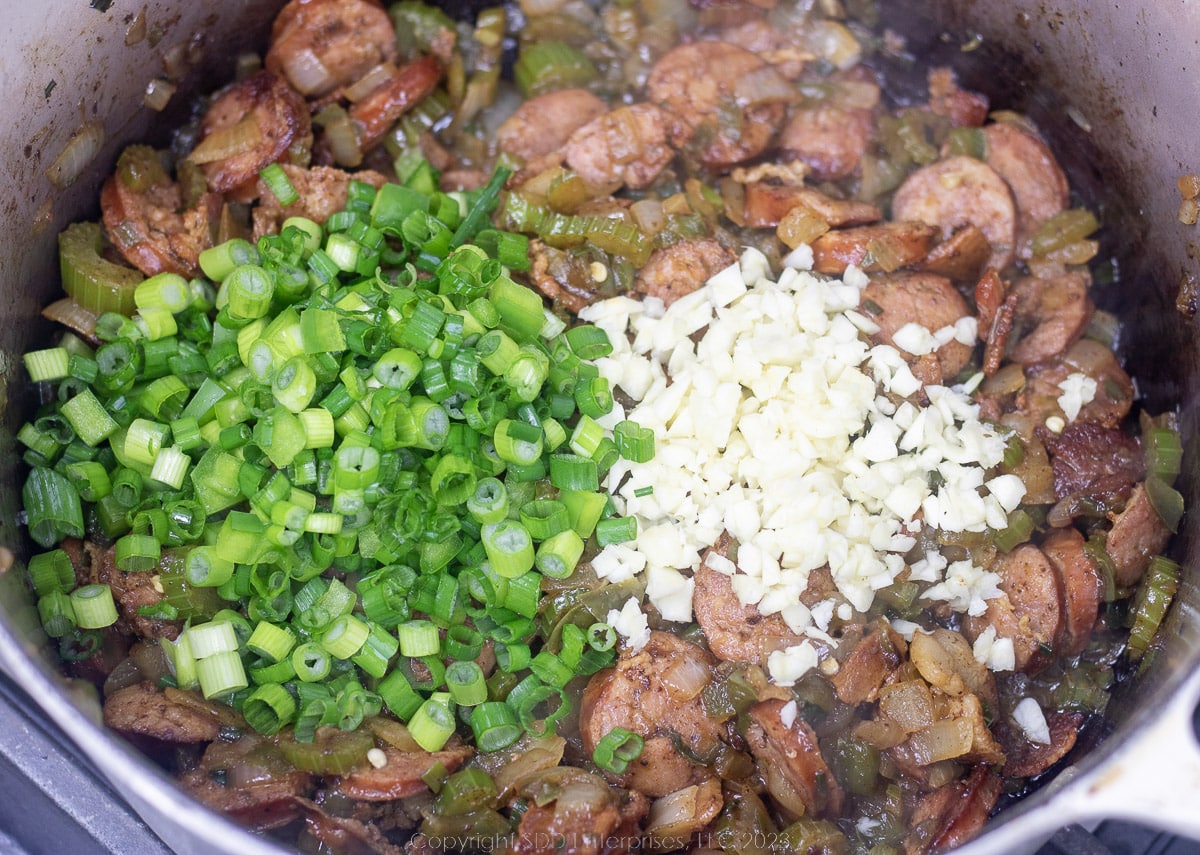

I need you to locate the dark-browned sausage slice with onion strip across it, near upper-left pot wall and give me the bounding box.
[193,71,312,193]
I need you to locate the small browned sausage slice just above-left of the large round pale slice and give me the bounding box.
[778,107,875,181]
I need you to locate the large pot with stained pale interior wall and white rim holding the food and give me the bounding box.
[0,0,1200,855]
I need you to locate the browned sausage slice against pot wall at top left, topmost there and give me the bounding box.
[264,0,396,98]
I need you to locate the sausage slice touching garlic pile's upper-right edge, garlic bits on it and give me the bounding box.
[863,273,971,378]
